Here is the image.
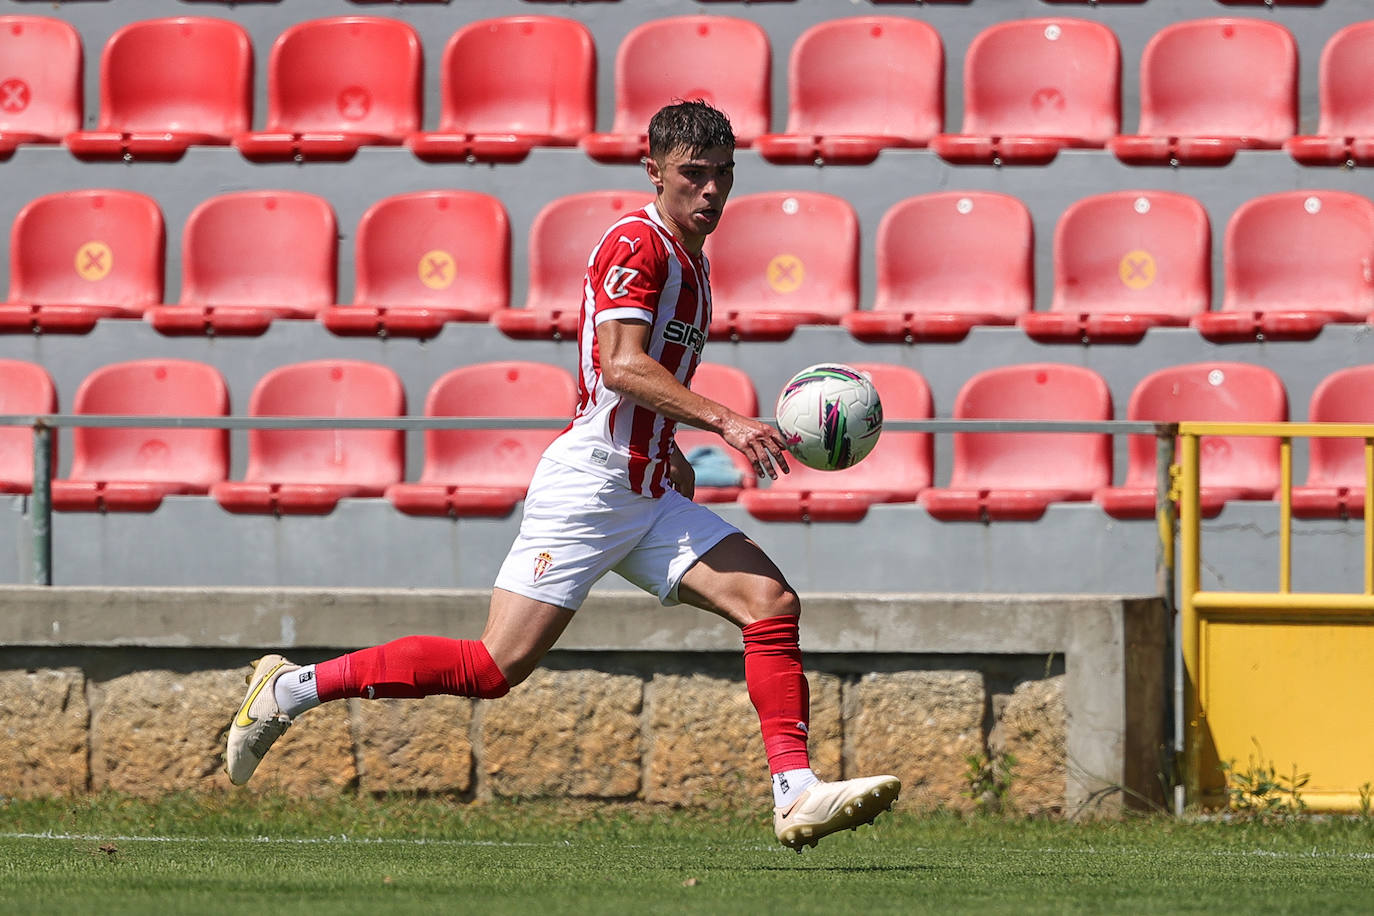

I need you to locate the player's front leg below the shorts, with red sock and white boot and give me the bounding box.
[677,534,901,853]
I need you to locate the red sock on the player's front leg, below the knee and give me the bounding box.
[743,614,811,773]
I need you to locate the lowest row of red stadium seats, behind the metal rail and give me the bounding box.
[0,360,1374,522]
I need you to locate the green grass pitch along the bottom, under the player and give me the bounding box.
[0,795,1374,916]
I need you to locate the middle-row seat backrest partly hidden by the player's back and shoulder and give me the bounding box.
[525,191,653,312]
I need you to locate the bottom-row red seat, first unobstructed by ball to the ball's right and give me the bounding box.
[919,363,1112,522]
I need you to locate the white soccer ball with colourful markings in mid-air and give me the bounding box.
[774,363,882,471]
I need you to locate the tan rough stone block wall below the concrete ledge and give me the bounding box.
[0,658,1066,813]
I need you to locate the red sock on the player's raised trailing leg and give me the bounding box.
[315,636,510,702]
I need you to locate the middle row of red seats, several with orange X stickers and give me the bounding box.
[0,190,1374,342]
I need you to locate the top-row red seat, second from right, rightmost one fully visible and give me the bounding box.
[1107,18,1297,165]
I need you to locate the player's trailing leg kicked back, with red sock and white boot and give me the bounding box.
[224,588,573,786]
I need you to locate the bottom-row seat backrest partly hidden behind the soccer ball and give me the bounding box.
[768,363,934,496]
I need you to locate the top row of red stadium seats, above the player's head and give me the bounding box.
[0,15,1374,165]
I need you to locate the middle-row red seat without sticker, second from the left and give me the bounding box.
[146,191,338,335]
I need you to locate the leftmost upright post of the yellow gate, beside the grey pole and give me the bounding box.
[1179,424,1202,805]
